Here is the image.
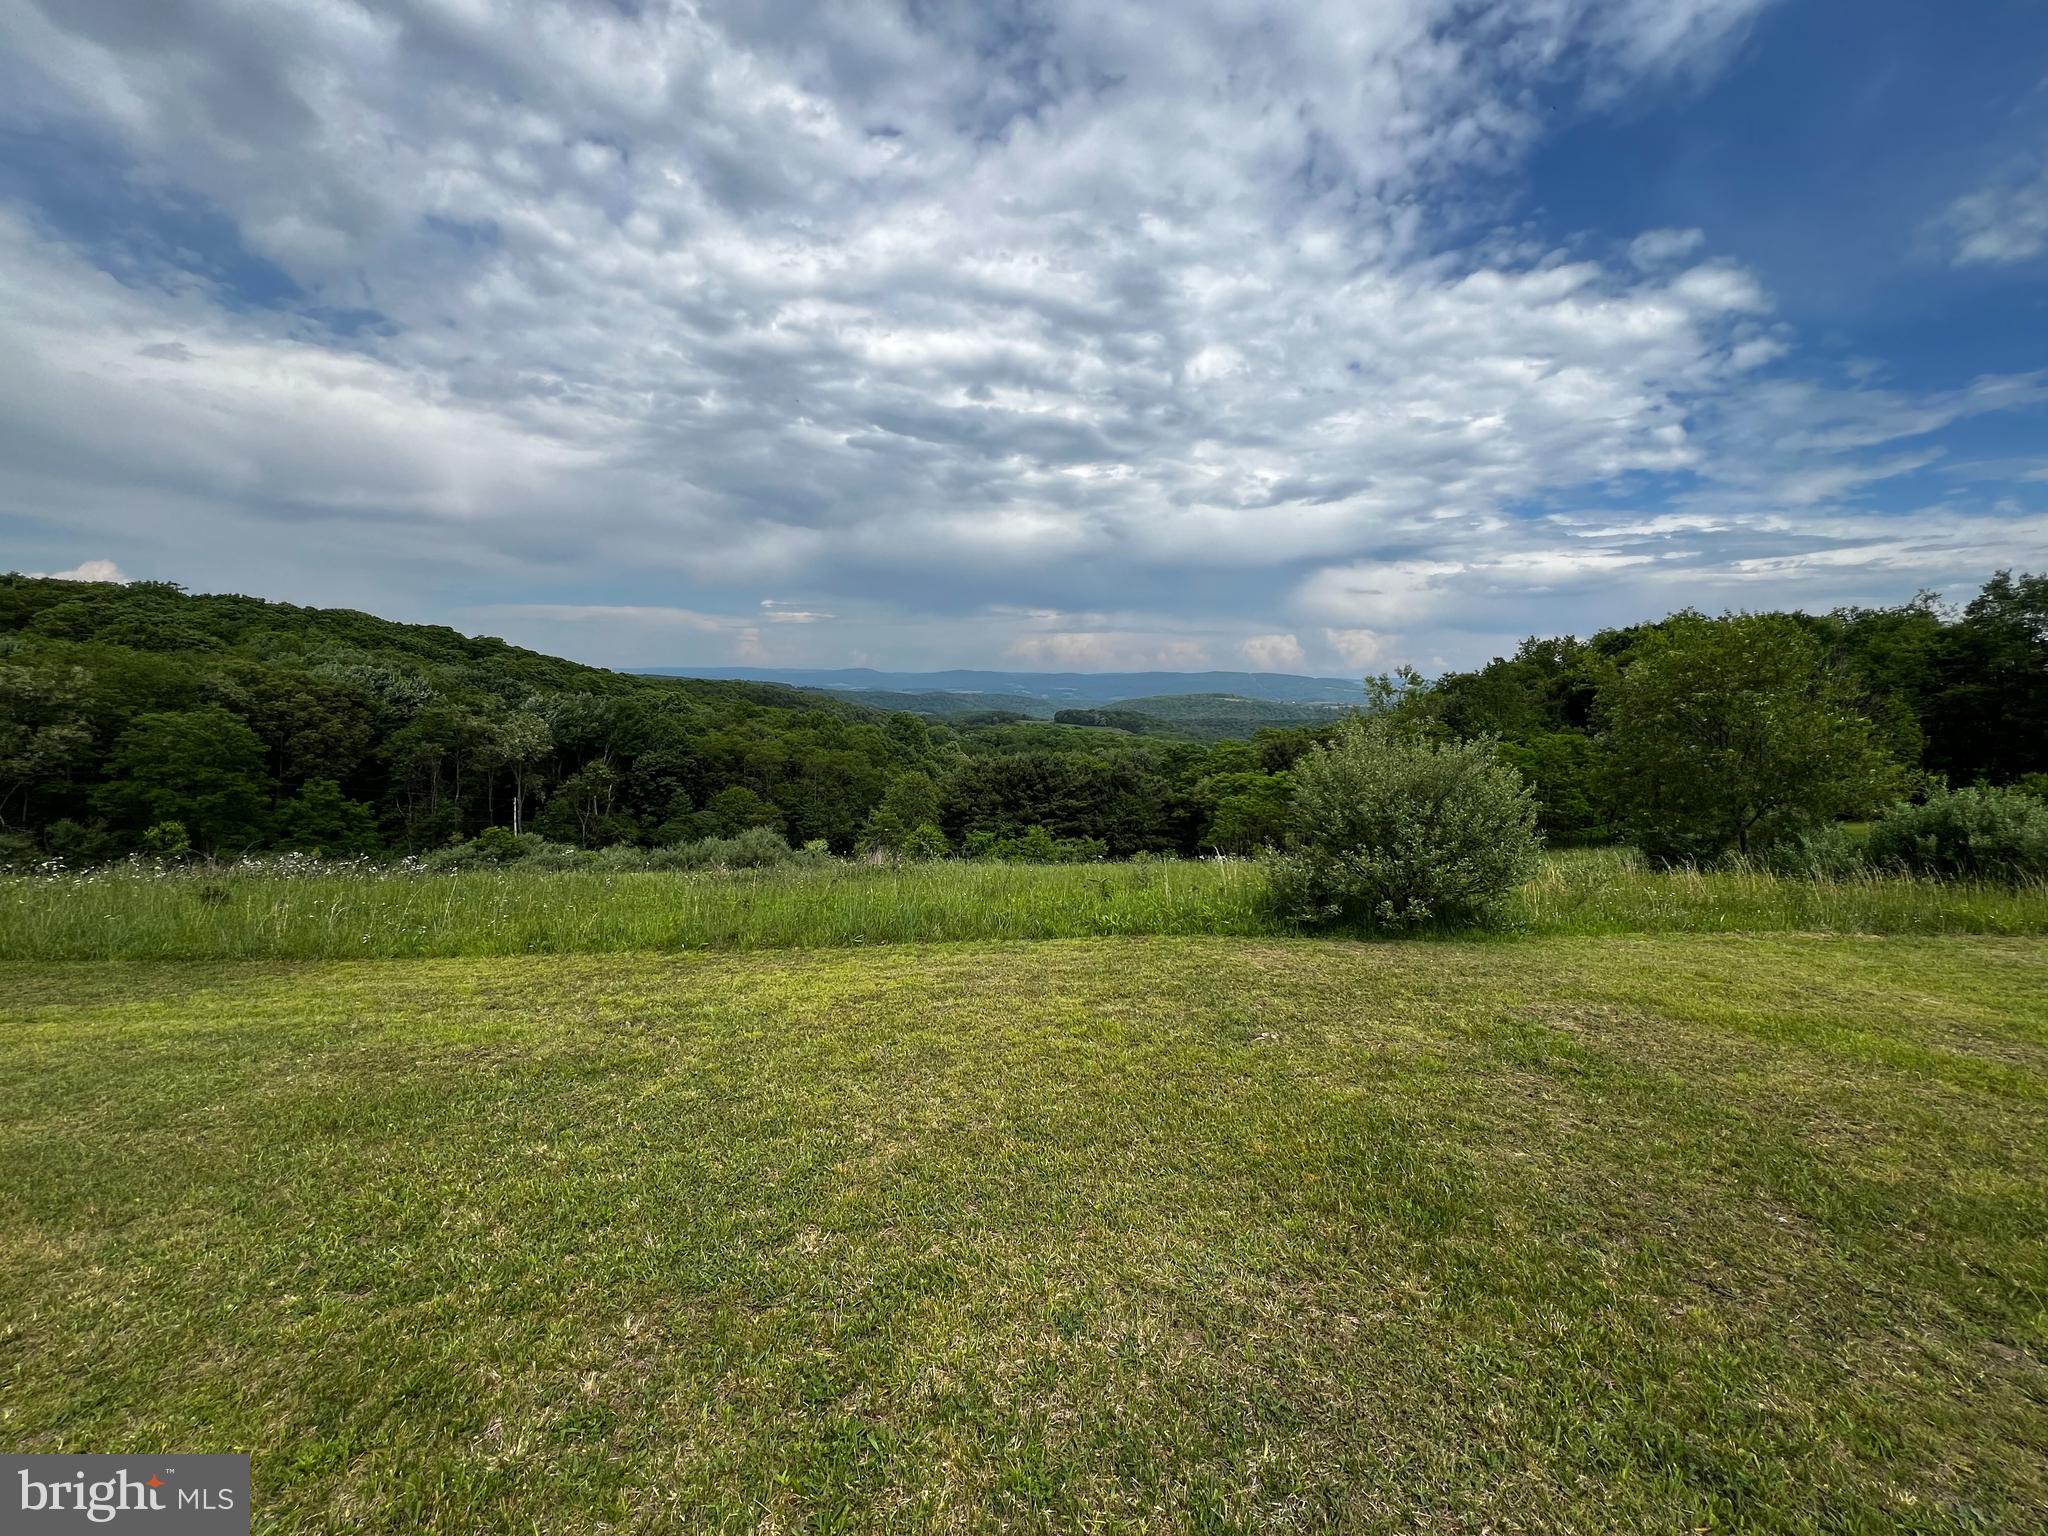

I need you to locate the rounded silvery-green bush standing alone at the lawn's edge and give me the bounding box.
[1276,721,1538,928]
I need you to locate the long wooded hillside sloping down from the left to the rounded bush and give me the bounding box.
[0,575,1307,866]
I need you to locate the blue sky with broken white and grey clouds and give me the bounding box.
[0,0,2048,676]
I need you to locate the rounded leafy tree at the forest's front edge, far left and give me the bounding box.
[94,705,270,854]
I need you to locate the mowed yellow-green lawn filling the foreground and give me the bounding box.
[0,934,2048,1536]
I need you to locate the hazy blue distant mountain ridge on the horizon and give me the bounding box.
[635,668,1364,713]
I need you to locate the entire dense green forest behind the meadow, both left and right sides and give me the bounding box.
[0,573,2048,864]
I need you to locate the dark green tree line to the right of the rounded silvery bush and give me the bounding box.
[1368,571,2048,860]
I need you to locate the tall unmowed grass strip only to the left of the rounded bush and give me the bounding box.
[0,860,1280,961]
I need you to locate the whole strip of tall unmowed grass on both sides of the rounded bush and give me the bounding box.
[0,850,2048,961]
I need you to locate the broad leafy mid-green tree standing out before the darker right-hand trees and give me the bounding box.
[1599,612,1903,860]
